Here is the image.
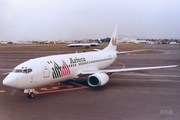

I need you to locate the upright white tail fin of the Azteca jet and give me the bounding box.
[103,25,118,51]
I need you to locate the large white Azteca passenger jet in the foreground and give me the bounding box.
[2,25,178,98]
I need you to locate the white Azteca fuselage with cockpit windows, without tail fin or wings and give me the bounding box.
[5,51,117,89]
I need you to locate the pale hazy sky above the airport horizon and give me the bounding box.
[0,0,180,41]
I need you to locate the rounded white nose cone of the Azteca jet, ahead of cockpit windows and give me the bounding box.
[2,74,17,88]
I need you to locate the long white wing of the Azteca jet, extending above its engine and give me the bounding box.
[78,65,178,76]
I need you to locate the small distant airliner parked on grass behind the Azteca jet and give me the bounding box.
[67,43,99,48]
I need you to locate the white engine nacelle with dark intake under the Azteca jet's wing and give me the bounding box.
[87,73,109,87]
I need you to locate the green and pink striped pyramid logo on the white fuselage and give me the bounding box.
[48,60,71,79]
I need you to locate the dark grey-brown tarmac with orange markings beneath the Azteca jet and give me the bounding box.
[0,45,180,120]
